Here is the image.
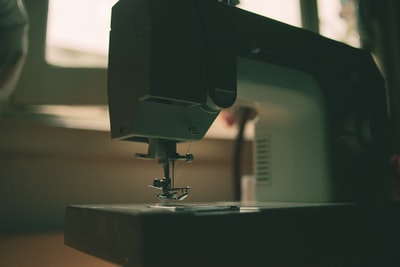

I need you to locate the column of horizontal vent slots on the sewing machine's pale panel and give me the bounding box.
[254,136,271,182]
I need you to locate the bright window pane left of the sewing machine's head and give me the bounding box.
[46,0,117,67]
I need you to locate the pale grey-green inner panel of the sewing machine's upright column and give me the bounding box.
[238,58,335,202]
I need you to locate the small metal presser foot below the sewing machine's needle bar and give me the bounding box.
[149,178,190,200]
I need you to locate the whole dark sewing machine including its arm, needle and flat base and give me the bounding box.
[65,0,397,266]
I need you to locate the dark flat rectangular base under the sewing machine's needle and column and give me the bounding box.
[65,203,400,267]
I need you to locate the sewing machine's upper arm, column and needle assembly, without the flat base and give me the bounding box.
[108,0,387,202]
